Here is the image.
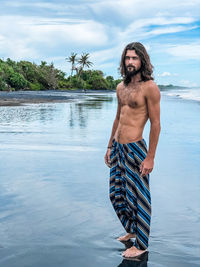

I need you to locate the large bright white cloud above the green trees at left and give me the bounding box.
[0,16,107,60]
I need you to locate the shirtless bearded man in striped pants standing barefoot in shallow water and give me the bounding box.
[105,42,160,257]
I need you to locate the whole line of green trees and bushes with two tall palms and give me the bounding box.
[0,53,121,91]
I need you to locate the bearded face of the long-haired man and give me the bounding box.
[125,50,141,75]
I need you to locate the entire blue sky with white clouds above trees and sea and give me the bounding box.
[0,0,200,87]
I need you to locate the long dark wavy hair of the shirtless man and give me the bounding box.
[120,42,154,85]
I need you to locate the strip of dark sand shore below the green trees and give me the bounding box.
[0,89,115,107]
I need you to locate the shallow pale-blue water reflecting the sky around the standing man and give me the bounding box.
[0,93,200,267]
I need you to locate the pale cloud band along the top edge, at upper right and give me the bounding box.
[90,0,200,20]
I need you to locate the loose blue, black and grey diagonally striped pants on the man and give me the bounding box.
[110,139,151,249]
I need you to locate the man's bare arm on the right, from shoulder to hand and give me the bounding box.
[140,81,161,176]
